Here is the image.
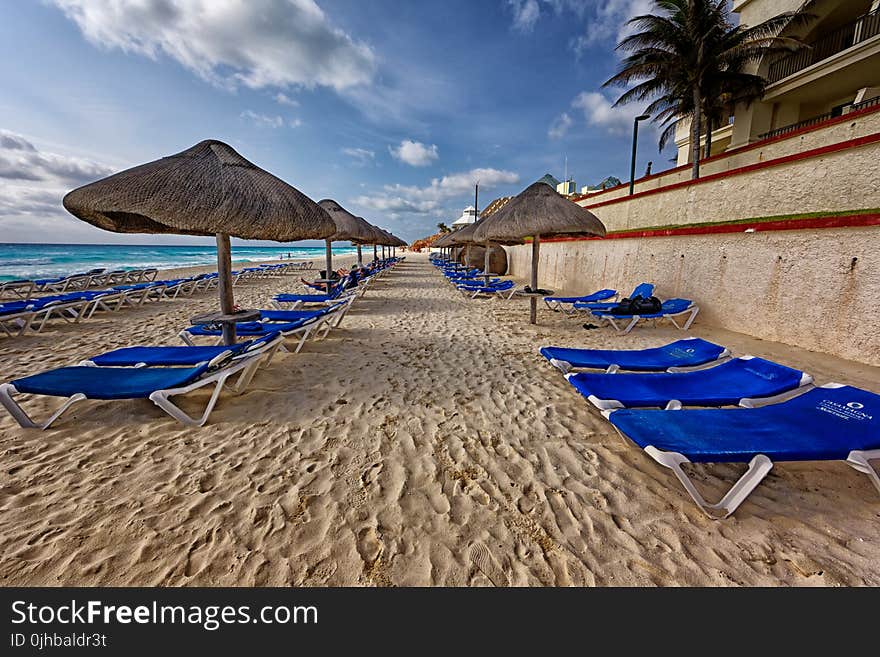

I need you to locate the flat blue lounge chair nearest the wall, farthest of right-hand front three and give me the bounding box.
[540,338,730,374]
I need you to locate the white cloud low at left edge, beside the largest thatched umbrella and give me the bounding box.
[0,130,113,226]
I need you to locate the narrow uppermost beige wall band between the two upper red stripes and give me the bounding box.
[592,106,880,207]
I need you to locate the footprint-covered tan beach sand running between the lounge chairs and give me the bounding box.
[0,255,880,586]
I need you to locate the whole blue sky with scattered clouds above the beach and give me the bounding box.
[0,0,672,243]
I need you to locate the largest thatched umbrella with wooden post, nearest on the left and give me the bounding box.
[63,140,335,344]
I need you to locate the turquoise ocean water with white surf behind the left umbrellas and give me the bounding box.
[0,243,360,281]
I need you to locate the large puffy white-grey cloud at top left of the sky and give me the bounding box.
[52,0,376,91]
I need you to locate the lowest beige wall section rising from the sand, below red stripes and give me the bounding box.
[508,227,880,365]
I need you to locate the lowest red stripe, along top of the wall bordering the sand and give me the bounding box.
[541,213,880,242]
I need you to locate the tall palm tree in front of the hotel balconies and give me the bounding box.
[604,0,813,178]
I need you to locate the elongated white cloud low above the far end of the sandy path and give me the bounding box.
[352,168,520,218]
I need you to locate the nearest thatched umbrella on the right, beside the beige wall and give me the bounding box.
[474,183,605,324]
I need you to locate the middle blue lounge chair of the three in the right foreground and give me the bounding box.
[565,356,813,411]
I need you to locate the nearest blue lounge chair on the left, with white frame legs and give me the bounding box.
[0,336,278,429]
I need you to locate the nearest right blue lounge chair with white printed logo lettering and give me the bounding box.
[604,383,880,519]
